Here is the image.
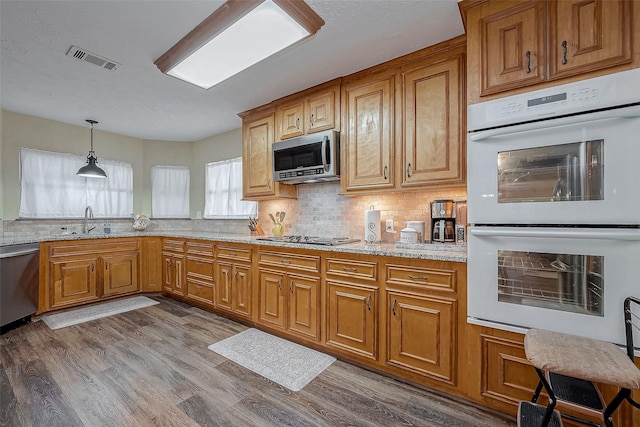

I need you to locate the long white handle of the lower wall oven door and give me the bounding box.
[469,227,640,241]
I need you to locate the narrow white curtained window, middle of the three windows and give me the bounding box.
[151,166,190,218]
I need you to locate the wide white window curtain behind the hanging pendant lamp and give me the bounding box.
[19,148,133,218]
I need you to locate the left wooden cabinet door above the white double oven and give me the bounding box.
[480,1,546,95]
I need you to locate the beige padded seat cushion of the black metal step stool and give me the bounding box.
[524,329,640,390]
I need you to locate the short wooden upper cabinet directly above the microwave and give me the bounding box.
[276,84,340,141]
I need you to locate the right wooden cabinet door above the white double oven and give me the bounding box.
[548,0,632,79]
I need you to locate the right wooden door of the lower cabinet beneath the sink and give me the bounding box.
[102,254,140,296]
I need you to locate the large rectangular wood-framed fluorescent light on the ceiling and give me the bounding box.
[154,0,324,89]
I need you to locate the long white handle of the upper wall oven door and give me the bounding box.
[469,105,640,142]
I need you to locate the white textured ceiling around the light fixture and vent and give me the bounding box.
[0,0,464,141]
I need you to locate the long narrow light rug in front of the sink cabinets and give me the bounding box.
[42,296,159,329]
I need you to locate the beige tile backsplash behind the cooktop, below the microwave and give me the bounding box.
[258,183,467,242]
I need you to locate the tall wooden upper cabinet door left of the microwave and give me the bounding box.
[242,114,275,198]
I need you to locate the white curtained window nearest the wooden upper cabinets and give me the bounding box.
[203,157,258,219]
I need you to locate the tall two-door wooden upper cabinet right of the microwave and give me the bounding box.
[340,37,466,194]
